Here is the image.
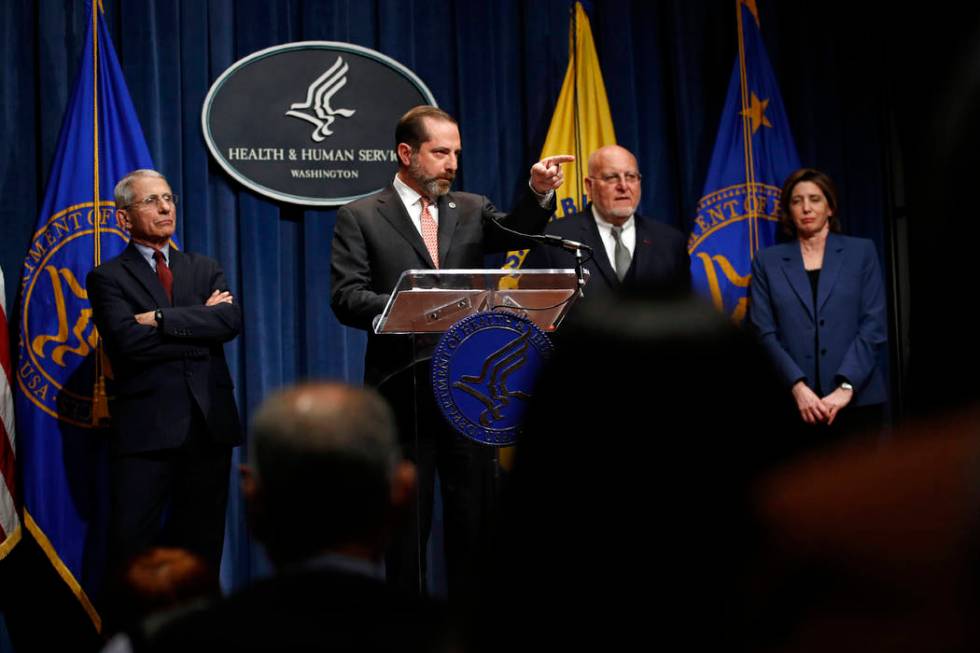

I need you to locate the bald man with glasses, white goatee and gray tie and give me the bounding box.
[524,145,691,297]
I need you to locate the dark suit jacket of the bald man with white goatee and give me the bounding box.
[523,204,691,297]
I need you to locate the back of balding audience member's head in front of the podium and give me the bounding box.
[250,383,401,558]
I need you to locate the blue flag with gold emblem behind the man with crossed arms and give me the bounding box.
[16,2,159,629]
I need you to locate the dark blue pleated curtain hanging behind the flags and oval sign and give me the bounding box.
[0,0,916,640]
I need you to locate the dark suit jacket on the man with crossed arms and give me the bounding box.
[86,243,241,454]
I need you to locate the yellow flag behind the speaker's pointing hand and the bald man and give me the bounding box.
[503,2,616,276]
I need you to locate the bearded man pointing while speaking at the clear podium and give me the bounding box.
[331,106,574,595]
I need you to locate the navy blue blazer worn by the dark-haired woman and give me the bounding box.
[749,233,888,406]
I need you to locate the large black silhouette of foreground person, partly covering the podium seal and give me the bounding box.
[470,295,793,650]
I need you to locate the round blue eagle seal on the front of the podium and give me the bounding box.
[432,311,553,447]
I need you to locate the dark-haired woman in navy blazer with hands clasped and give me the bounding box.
[749,168,888,430]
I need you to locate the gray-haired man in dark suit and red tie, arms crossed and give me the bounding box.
[86,170,242,574]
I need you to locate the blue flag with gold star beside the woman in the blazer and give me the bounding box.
[688,0,800,322]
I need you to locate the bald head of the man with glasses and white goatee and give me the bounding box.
[585,145,641,225]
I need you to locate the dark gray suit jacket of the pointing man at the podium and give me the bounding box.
[330,186,553,385]
